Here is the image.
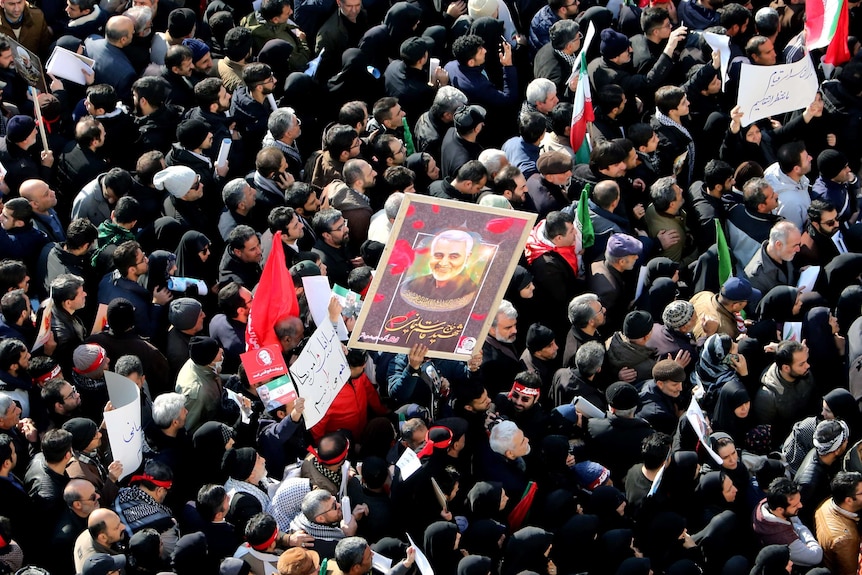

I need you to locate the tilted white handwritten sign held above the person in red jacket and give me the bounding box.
[290,322,350,429]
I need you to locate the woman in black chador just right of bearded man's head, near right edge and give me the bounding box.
[802,307,847,391]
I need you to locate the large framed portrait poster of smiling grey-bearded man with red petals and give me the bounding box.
[349,194,536,361]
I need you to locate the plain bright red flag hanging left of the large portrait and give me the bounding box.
[245,232,299,349]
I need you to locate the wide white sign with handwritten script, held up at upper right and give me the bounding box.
[737,56,817,126]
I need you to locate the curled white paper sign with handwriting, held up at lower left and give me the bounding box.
[104,371,144,479]
